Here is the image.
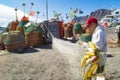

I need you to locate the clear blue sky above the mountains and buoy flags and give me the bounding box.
[0,0,120,20]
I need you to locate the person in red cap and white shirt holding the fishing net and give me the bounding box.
[86,17,107,73]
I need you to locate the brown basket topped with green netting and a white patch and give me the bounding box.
[24,22,43,46]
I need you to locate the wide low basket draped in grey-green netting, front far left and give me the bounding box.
[1,31,26,51]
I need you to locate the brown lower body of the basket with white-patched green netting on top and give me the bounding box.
[25,31,43,46]
